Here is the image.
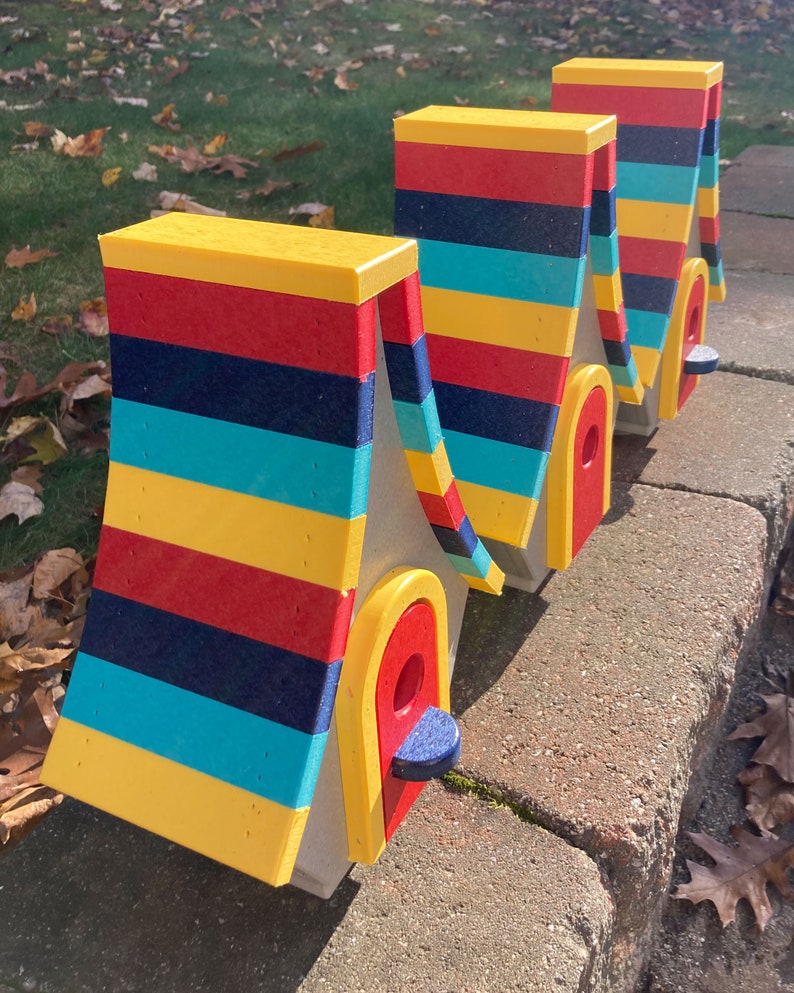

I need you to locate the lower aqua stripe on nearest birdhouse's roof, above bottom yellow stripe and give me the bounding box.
[64,656,328,809]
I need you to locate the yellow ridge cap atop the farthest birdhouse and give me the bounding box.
[551,59,723,90]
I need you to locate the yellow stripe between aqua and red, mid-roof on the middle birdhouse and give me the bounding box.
[422,286,579,355]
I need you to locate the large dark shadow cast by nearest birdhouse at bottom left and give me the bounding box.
[0,800,359,993]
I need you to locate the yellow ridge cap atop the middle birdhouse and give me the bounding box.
[394,107,617,155]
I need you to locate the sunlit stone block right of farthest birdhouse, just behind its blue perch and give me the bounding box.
[696,270,794,393]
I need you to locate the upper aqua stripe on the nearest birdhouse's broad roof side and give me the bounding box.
[110,397,372,518]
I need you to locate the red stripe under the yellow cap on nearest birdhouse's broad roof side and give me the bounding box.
[105,268,375,377]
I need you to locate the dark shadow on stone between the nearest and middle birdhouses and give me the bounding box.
[450,587,548,714]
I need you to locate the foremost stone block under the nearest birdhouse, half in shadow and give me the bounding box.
[0,784,613,993]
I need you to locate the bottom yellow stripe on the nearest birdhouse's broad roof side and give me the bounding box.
[42,717,309,886]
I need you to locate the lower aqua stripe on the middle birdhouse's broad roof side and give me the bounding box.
[444,431,549,500]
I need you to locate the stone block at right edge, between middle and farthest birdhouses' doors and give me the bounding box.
[612,372,794,569]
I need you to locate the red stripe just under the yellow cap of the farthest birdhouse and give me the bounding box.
[551,83,708,128]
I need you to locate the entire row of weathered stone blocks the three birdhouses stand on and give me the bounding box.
[0,146,794,993]
